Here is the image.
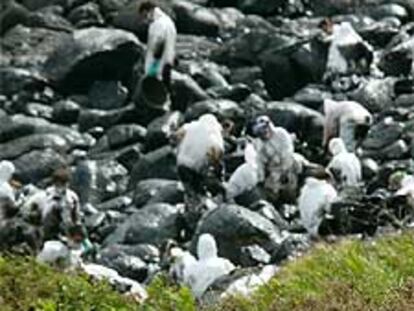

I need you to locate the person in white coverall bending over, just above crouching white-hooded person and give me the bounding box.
[323,99,372,152]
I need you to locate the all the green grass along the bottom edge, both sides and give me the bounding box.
[0,232,414,311]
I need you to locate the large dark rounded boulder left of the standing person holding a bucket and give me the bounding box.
[45,27,143,91]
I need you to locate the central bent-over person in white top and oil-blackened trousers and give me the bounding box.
[175,114,224,239]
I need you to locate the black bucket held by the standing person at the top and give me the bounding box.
[139,77,169,109]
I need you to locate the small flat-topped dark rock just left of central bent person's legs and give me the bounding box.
[134,179,184,208]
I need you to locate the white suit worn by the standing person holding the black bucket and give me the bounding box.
[145,7,177,80]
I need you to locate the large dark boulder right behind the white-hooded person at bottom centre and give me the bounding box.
[191,205,283,264]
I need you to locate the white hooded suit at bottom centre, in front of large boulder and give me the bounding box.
[185,233,235,298]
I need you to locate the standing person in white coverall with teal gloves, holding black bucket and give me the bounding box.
[138,1,177,89]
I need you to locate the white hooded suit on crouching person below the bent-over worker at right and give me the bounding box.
[328,138,362,186]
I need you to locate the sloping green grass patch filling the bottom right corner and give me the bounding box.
[213,232,414,311]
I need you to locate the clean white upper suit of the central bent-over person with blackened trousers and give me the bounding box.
[177,114,224,172]
